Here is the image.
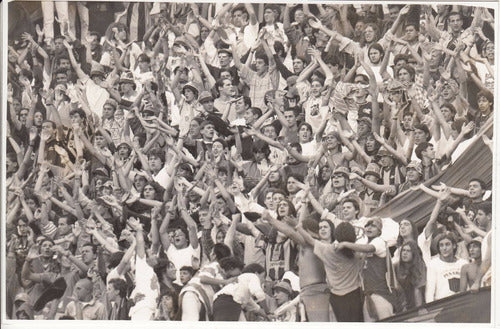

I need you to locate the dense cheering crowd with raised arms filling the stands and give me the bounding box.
[4,1,495,322]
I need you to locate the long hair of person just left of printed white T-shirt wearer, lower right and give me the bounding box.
[395,240,427,286]
